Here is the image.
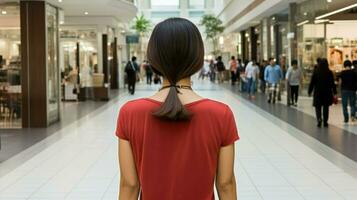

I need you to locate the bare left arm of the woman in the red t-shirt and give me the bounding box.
[118,139,140,200]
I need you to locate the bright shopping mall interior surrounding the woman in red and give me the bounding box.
[0,0,357,200]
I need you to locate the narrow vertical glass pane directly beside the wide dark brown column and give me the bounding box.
[46,4,60,123]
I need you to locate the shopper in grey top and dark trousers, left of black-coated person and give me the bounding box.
[286,60,303,106]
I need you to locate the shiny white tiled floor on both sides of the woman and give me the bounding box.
[0,83,357,200]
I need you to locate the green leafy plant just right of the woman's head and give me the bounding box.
[200,15,224,55]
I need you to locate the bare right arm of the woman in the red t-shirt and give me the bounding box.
[216,144,237,200]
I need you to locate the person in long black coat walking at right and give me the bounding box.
[309,58,337,127]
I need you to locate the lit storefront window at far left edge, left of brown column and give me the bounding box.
[0,3,22,128]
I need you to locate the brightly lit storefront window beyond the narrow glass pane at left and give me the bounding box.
[60,27,98,100]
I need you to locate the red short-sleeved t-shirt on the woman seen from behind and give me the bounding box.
[116,98,239,200]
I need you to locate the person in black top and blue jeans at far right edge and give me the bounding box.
[340,60,357,123]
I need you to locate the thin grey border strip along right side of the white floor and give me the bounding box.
[223,88,357,177]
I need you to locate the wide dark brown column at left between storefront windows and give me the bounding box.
[20,1,60,128]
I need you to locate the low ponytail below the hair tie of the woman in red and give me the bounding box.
[153,85,191,120]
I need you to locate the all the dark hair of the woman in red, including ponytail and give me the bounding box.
[147,18,204,120]
